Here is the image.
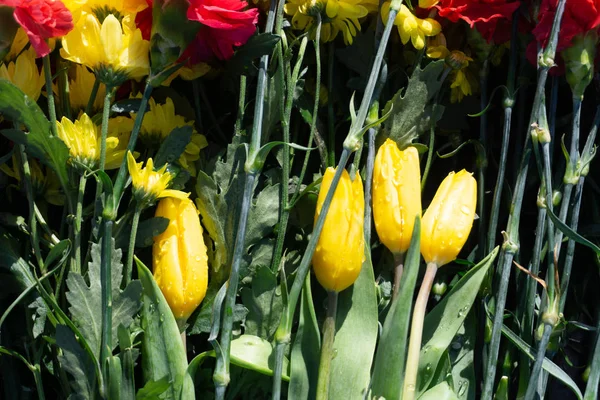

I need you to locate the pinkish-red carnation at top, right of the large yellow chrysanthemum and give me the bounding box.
[187,0,258,62]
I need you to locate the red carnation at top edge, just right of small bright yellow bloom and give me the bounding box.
[436,0,520,42]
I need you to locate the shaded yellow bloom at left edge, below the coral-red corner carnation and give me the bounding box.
[0,48,45,101]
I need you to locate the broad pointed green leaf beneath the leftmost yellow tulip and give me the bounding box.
[135,258,195,400]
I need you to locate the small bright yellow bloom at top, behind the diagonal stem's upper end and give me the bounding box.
[381,2,442,50]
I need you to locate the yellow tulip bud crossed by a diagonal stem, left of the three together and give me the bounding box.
[312,168,365,292]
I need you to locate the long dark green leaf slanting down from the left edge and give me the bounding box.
[0,78,70,191]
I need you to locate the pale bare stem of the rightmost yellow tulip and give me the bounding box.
[402,262,438,400]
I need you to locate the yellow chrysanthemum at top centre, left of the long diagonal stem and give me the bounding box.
[284,0,372,44]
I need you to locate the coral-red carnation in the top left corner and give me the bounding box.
[0,0,73,57]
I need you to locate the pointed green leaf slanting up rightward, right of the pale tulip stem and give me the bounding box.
[416,247,498,397]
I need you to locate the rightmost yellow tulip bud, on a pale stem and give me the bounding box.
[421,169,477,267]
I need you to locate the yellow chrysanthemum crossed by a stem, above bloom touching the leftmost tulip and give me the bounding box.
[56,113,127,169]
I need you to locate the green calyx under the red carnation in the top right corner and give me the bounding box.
[561,31,598,98]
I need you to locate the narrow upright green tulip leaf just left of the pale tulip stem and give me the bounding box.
[371,217,421,400]
